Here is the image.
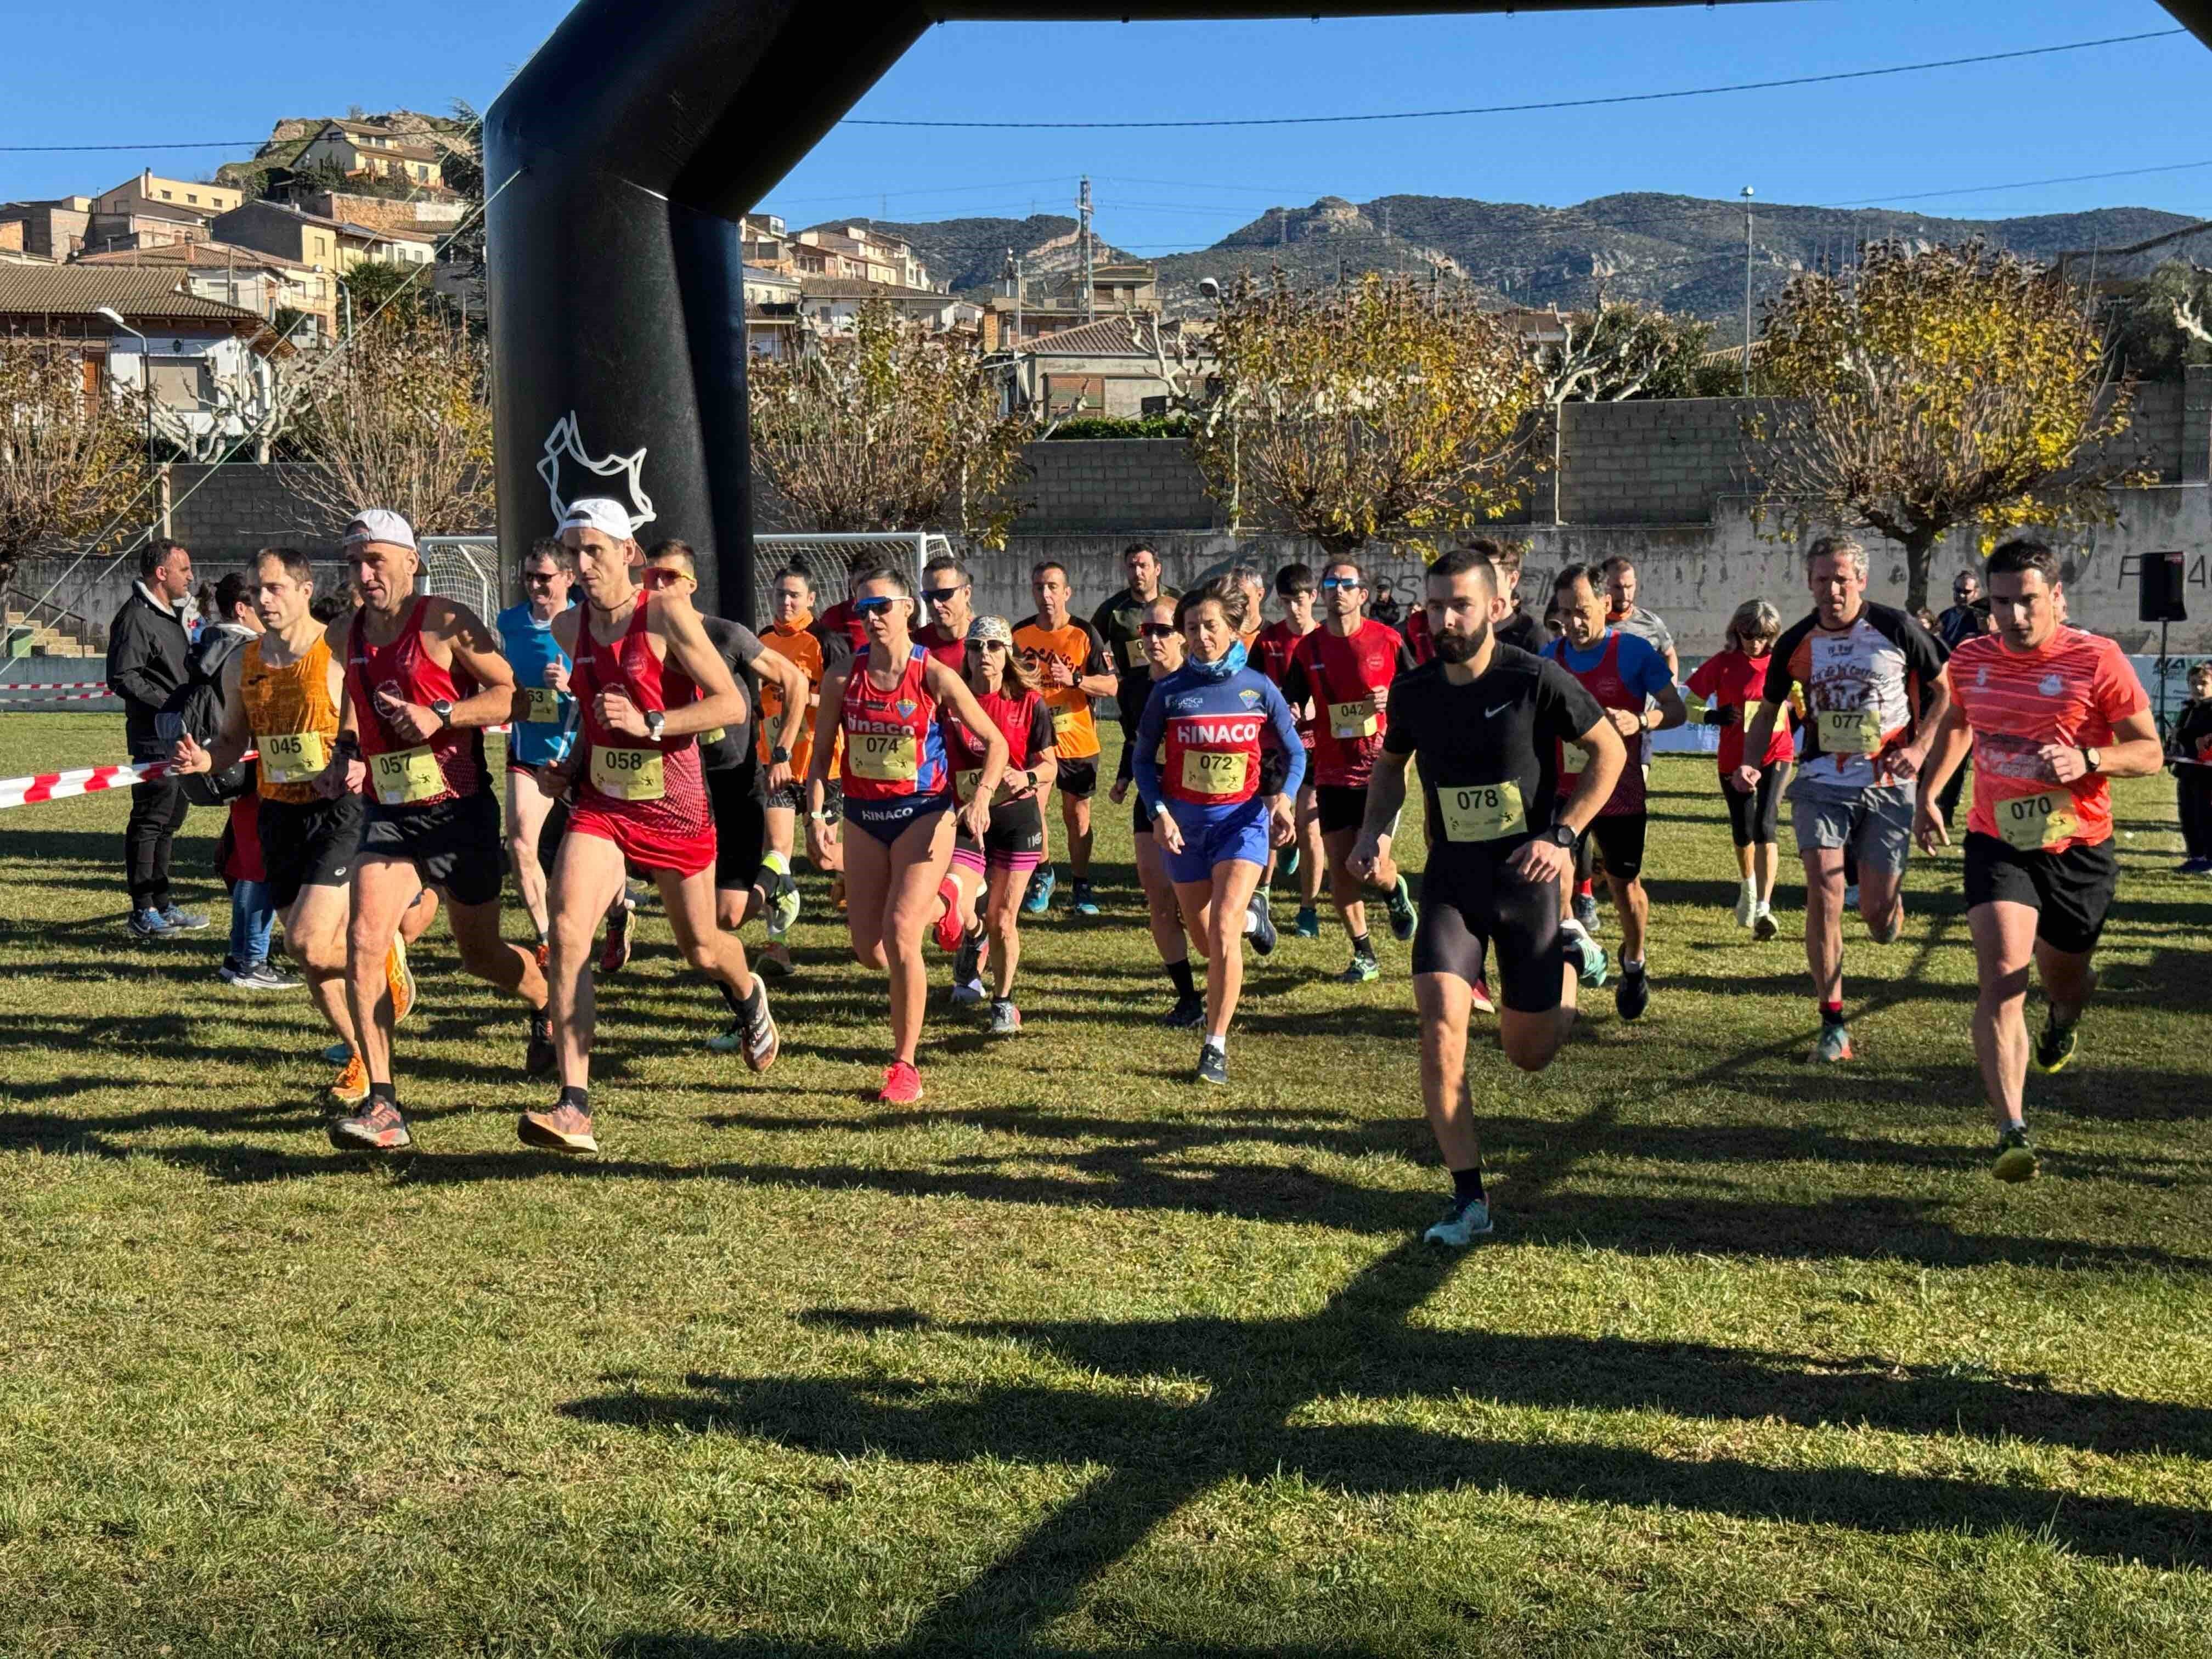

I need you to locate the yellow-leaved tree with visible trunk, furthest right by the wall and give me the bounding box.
[1745,241,2146,611]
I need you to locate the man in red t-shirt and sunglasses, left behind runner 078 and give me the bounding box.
[1283,560,1413,984]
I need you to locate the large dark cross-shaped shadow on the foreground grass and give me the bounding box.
[560,1243,2212,1652]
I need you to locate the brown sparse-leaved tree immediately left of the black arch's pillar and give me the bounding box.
[292,312,498,535]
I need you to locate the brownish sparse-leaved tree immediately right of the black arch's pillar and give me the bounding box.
[748,301,1037,546]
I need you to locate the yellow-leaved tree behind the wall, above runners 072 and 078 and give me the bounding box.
[1190,272,1544,555]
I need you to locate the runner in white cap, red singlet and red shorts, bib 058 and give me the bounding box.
[515,498,778,1153]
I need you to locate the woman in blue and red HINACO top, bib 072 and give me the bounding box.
[1135,579,1305,1084]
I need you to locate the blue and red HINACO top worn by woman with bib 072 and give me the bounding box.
[1130,668,1305,823]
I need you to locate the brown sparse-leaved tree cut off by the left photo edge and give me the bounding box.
[0,334,150,593]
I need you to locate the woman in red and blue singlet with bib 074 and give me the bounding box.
[808,571,1007,1104]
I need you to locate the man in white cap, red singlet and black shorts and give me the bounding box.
[321,506,553,1153]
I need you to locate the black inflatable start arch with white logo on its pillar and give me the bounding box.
[484,0,2212,622]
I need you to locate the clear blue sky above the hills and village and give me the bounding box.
[0,0,2212,252]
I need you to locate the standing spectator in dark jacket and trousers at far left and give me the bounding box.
[109,542,208,938]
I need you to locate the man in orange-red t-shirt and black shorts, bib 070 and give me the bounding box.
[1914,540,2165,1181]
